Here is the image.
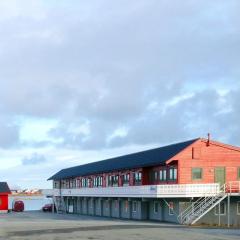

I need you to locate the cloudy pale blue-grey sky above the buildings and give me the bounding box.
[0,0,240,189]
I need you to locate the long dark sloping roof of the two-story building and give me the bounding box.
[48,139,198,180]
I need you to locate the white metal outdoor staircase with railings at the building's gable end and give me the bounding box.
[178,182,240,225]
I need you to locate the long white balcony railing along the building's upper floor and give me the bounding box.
[54,183,220,198]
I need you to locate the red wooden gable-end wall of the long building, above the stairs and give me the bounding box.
[173,140,240,184]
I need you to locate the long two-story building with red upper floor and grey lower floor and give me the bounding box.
[49,138,240,225]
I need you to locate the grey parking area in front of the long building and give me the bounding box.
[0,212,240,240]
